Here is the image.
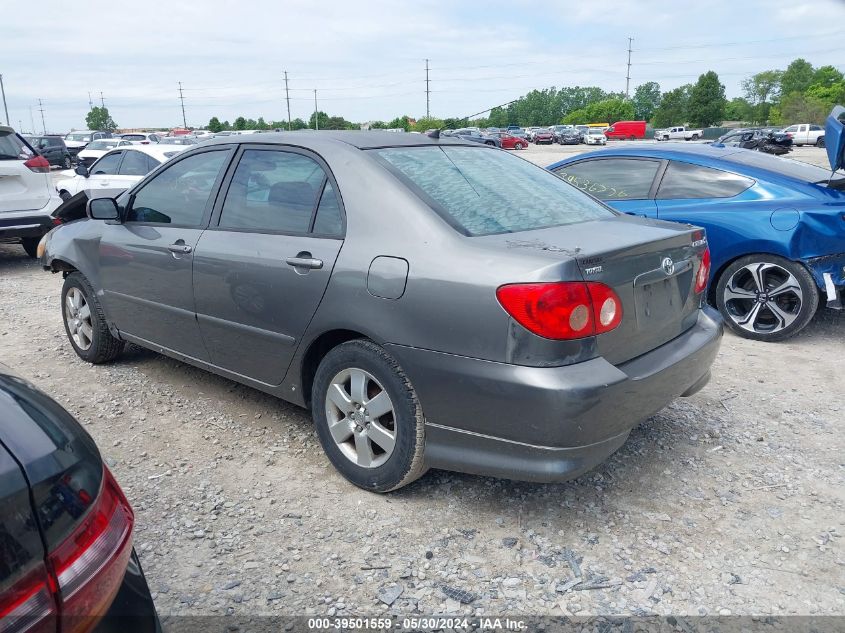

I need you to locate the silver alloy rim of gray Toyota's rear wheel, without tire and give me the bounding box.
[325,368,396,468]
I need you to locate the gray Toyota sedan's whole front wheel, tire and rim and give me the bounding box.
[62,271,125,365]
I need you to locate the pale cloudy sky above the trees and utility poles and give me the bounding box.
[0,0,845,132]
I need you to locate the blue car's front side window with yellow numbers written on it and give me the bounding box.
[554,158,660,200]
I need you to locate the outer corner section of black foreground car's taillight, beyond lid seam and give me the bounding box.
[49,467,134,623]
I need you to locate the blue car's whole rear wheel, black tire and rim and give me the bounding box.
[716,254,819,341]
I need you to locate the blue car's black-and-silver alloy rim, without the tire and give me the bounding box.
[722,262,804,334]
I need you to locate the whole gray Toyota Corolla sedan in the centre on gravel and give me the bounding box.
[41,132,722,492]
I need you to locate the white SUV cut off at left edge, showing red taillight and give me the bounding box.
[0,125,62,257]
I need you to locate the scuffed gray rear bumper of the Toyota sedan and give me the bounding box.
[387,308,722,481]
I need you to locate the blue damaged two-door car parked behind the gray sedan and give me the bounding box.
[548,106,845,341]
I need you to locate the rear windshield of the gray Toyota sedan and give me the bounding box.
[375,146,614,235]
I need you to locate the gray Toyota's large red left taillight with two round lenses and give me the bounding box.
[496,281,622,340]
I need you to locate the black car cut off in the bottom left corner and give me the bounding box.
[0,364,160,633]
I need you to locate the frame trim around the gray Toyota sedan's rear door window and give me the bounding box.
[208,143,346,240]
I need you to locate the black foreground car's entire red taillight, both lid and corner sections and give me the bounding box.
[0,467,134,633]
